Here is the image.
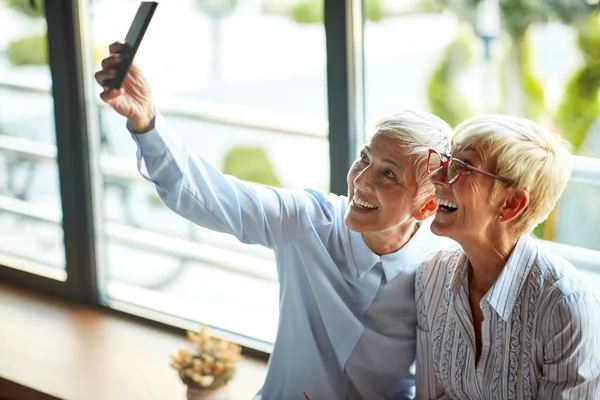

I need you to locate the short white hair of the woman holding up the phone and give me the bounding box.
[375,110,452,206]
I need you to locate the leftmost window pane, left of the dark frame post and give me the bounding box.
[0,0,67,281]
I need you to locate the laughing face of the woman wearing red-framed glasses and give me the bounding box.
[430,150,499,244]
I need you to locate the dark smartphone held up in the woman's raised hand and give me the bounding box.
[104,1,158,89]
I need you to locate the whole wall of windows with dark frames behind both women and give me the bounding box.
[0,0,600,351]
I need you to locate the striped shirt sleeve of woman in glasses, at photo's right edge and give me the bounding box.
[539,293,600,400]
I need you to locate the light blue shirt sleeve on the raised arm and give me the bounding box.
[129,113,335,248]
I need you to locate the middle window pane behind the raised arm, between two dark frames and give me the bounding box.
[89,0,329,343]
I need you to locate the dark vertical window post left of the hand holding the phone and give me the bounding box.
[45,0,98,302]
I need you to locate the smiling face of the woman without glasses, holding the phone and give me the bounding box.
[344,133,417,234]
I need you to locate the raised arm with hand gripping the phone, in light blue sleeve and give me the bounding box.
[96,43,331,247]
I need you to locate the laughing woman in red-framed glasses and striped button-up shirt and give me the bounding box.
[416,115,600,400]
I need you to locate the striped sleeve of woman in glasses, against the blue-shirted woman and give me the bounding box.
[415,257,448,400]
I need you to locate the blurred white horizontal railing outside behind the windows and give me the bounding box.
[0,81,600,281]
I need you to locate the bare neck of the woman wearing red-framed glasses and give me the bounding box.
[461,235,519,296]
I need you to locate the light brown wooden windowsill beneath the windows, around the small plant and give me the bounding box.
[0,283,266,400]
